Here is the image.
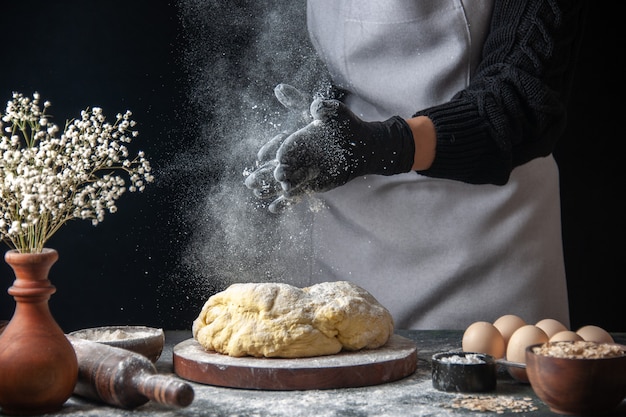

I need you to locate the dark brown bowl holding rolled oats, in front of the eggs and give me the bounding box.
[525,342,626,416]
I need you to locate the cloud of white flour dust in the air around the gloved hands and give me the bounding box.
[171,0,329,302]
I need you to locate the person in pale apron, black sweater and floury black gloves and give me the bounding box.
[246,0,583,329]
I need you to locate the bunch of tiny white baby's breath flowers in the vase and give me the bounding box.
[0,93,154,252]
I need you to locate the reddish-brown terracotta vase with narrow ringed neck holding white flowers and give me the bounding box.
[0,249,78,415]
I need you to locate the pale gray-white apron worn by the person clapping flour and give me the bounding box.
[303,0,569,329]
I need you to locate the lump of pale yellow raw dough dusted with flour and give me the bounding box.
[192,281,394,358]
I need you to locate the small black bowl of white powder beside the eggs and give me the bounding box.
[431,352,497,392]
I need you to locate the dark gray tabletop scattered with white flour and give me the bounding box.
[19,330,626,417]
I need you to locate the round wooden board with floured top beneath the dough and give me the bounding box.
[173,335,417,390]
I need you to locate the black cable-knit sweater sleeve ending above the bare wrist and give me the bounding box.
[415,0,585,185]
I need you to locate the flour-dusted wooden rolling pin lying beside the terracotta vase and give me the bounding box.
[68,336,194,409]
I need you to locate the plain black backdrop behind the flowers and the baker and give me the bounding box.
[0,0,626,332]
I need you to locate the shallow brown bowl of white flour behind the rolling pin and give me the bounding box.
[69,326,165,362]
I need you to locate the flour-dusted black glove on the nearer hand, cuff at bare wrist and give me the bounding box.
[274,99,415,200]
